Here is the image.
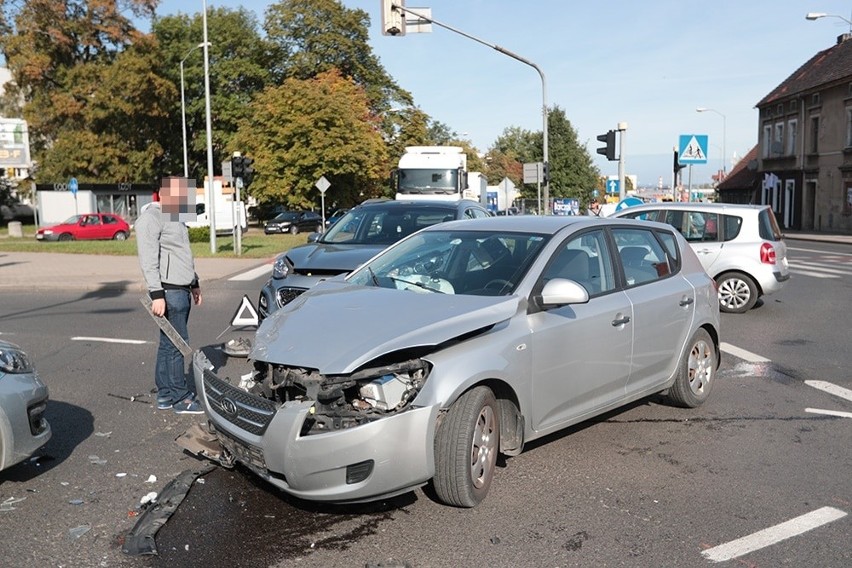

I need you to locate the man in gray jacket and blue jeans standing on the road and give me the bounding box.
[140,177,204,414]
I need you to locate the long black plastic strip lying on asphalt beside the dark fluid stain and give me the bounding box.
[121,465,215,556]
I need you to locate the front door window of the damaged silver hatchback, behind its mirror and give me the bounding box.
[542,230,615,297]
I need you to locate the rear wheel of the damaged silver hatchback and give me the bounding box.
[666,329,718,408]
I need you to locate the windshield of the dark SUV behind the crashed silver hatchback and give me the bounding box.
[320,205,456,245]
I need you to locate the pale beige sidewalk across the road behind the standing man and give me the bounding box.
[0,251,272,292]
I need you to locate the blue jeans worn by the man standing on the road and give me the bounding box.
[154,290,195,403]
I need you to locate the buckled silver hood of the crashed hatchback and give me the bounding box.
[249,281,519,374]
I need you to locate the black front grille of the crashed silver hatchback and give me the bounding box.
[204,370,278,436]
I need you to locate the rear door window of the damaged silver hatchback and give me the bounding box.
[612,228,672,286]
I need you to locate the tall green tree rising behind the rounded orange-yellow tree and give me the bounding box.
[264,0,413,114]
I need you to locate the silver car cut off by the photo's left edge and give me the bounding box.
[0,340,51,470]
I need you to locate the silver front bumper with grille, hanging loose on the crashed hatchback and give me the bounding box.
[193,351,439,503]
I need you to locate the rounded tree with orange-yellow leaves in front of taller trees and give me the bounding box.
[233,70,389,208]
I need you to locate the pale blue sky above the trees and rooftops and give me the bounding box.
[157,0,852,186]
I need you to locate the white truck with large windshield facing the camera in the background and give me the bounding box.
[391,146,486,202]
